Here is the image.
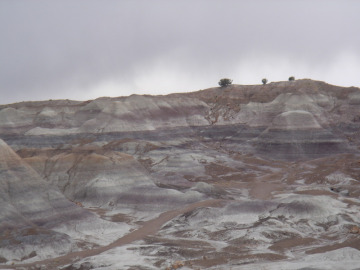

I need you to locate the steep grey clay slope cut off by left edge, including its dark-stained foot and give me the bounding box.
[0,140,134,262]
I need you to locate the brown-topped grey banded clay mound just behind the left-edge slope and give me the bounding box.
[19,146,202,212]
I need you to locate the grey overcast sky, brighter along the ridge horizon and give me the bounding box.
[0,0,360,104]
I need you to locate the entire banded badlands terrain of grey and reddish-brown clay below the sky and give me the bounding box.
[0,80,360,270]
